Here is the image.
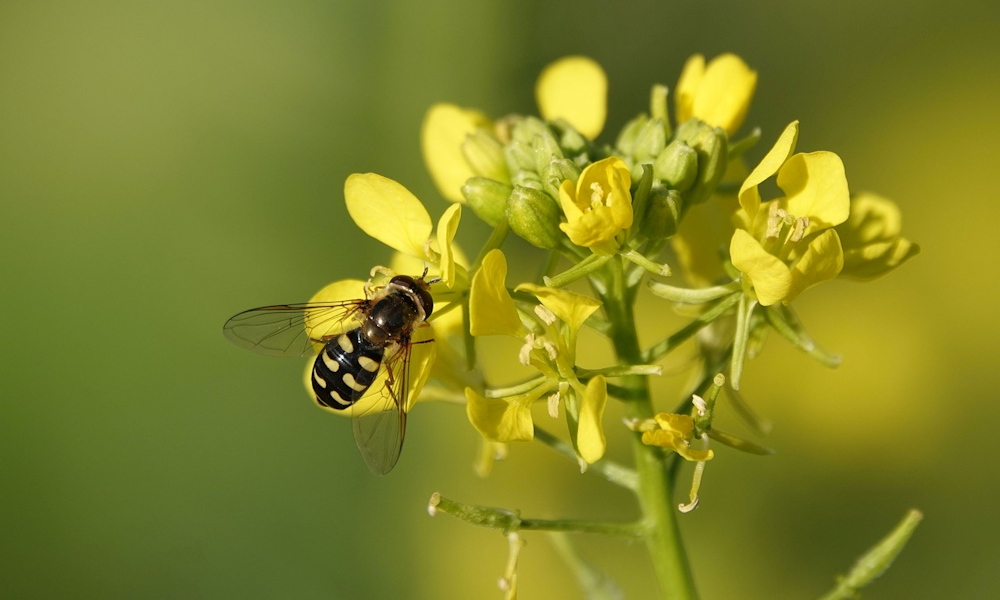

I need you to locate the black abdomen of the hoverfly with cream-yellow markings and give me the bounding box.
[312,327,385,410]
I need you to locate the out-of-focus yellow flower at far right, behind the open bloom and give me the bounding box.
[837,192,920,281]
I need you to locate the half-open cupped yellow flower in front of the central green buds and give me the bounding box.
[559,156,632,254]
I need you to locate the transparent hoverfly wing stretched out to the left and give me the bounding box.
[222,299,369,356]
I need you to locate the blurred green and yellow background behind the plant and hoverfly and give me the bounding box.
[0,0,1000,599]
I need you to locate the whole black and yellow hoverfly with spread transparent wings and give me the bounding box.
[223,270,437,475]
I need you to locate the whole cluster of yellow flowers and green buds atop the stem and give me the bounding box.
[316,49,919,482]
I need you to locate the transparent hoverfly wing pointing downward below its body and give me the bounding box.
[351,343,411,475]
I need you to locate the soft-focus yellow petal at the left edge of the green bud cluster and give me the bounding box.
[420,104,492,202]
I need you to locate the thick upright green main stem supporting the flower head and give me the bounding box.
[602,262,697,600]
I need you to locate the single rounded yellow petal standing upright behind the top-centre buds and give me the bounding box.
[535,56,608,140]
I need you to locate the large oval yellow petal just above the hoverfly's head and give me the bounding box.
[344,173,434,258]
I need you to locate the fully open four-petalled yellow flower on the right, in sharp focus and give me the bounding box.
[729,121,850,306]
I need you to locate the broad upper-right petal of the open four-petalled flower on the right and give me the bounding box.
[778,152,851,233]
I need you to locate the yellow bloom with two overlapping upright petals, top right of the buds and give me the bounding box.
[675,54,757,137]
